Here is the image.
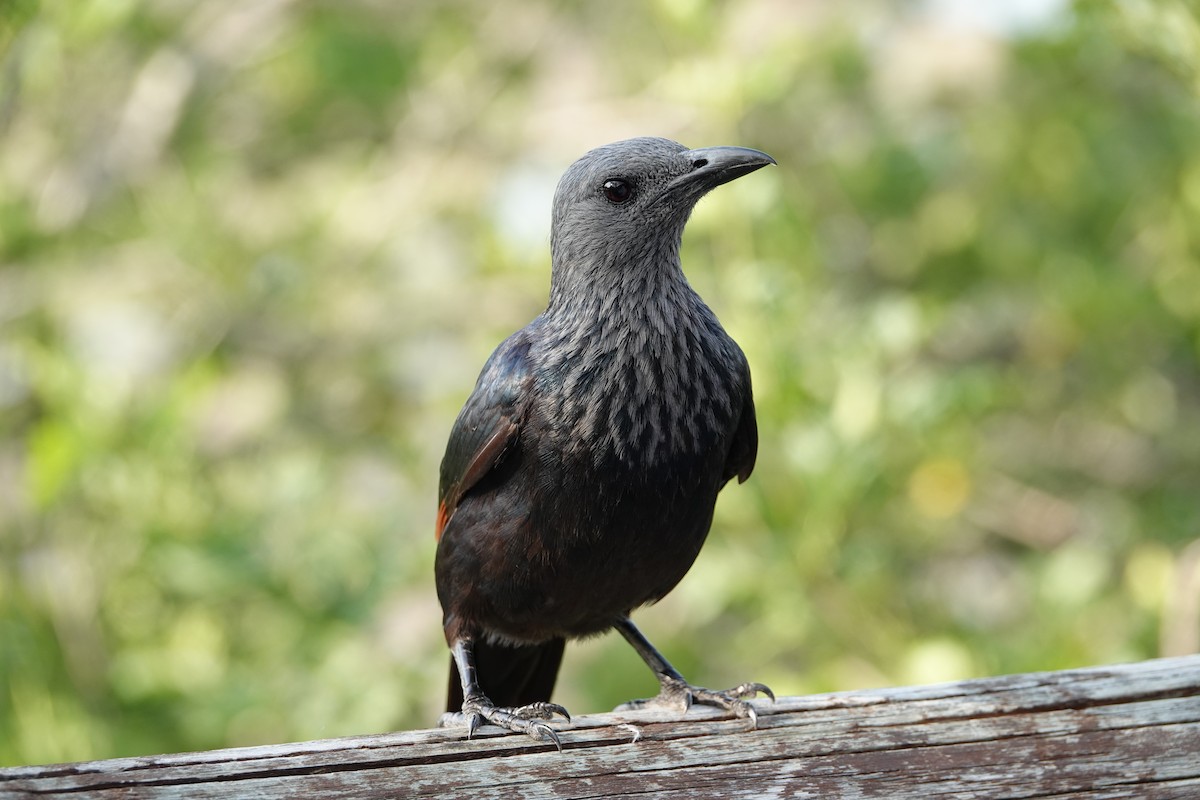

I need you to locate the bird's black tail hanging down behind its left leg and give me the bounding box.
[446,639,565,711]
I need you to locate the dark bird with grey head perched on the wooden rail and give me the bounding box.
[434,137,776,750]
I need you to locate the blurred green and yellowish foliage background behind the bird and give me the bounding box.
[0,0,1200,764]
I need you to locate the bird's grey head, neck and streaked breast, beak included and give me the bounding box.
[535,138,775,464]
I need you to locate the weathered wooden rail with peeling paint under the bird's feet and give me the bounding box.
[0,656,1200,800]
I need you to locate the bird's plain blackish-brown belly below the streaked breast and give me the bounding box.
[456,459,720,640]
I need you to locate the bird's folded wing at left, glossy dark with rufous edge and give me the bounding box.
[436,332,530,539]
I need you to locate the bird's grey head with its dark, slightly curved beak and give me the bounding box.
[551,137,775,299]
